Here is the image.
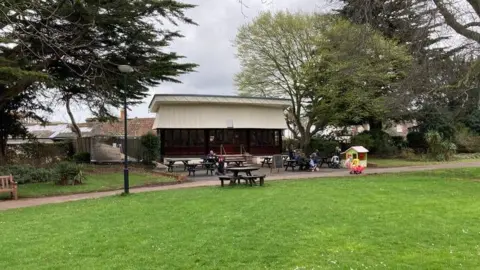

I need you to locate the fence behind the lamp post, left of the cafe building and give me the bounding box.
[74,136,146,163]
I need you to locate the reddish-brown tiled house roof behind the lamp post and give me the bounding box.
[95,118,155,137]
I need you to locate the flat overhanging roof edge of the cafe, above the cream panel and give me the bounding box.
[148,94,292,112]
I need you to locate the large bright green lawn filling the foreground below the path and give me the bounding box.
[0,169,480,270]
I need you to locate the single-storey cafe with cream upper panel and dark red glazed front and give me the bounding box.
[149,94,291,160]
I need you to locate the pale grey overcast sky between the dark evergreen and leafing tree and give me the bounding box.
[49,0,334,122]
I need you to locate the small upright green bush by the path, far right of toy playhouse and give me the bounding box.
[425,131,457,161]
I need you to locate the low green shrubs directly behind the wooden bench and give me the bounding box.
[0,165,56,184]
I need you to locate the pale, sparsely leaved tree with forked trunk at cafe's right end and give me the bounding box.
[235,12,329,148]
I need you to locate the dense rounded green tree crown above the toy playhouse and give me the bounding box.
[306,19,412,129]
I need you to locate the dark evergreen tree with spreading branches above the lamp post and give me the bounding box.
[0,0,196,136]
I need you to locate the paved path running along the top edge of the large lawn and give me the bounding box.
[0,161,480,211]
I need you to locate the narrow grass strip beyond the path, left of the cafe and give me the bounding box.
[0,173,175,199]
